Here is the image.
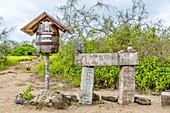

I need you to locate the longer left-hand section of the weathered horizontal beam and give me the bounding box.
[74,53,118,66]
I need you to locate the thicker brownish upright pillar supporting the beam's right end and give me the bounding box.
[118,66,135,105]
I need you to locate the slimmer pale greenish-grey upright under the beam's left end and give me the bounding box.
[79,66,94,104]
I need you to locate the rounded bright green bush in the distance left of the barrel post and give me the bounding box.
[10,44,36,56]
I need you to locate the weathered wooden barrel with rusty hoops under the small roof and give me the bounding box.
[36,32,59,53]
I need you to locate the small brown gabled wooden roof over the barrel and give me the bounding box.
[21,12,70,36]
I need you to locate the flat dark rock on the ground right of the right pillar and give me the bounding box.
[134,97,151,105]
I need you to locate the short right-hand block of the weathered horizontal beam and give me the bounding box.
[118,52,139,66]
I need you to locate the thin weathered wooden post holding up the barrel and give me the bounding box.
[45,53,50,90]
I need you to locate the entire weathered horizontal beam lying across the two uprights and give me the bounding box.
[74,53,139,66]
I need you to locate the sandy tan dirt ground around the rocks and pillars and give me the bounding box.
[0,60,170,113]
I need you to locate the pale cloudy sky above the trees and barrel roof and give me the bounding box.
[0,0,170,42]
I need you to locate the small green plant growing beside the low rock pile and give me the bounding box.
[21,85,35,100]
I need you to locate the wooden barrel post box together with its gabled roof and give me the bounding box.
[21,12,69,53]
